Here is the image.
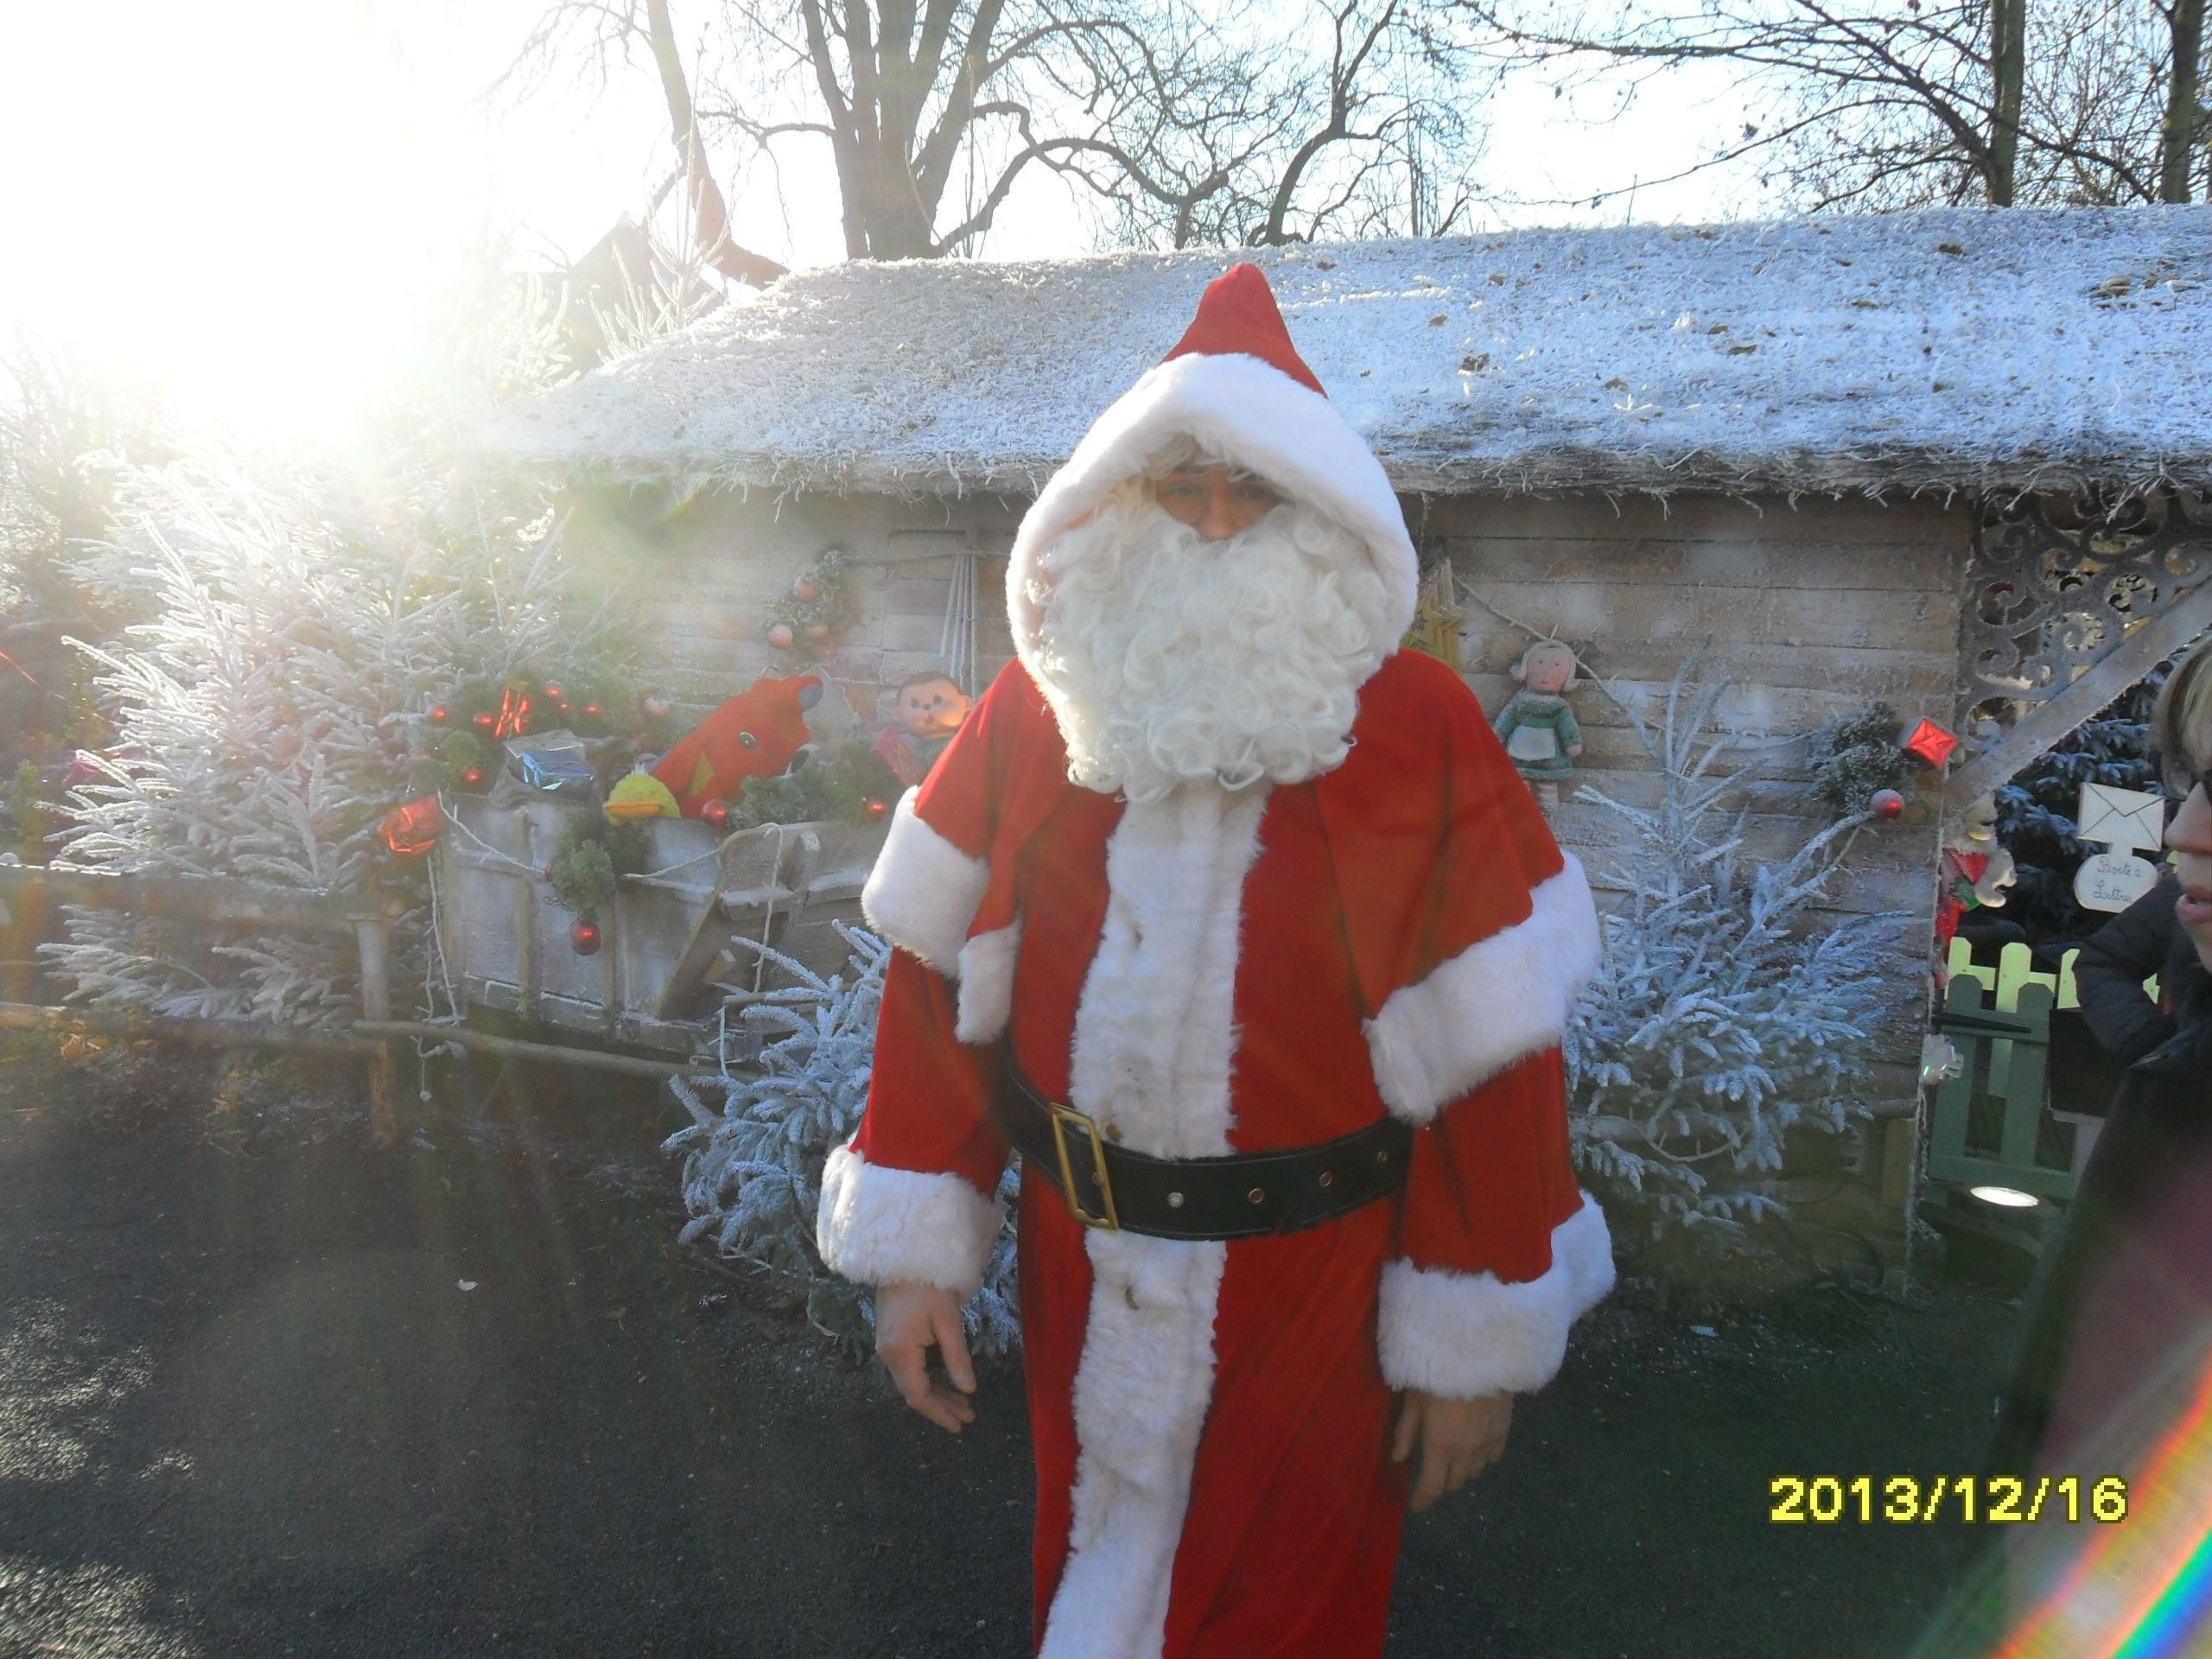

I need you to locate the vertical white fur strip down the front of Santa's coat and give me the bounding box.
[1042,783,1268,1659]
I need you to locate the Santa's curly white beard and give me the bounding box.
[1027,486,1398,801]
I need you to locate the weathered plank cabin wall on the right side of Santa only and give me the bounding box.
[1442,498,1971,1261]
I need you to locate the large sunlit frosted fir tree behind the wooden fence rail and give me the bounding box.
[47,256,621,1027]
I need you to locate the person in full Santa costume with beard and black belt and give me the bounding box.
[818,265,1612,1659]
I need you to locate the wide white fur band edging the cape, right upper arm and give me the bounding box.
[1367,854,1599,1126]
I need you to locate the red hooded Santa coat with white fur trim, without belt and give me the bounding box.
[817,265,1612,1659]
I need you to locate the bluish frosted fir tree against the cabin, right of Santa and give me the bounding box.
[1564,651,1907,1245]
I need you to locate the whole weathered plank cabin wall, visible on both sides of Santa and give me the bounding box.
[617,495,1971,1261]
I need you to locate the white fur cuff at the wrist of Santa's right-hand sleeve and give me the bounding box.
[1376,1192,1612,1400]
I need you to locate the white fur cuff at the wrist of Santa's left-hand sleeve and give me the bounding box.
[814,1146,1007,1300]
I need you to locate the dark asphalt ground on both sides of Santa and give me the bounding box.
[0,1042,2013,1659]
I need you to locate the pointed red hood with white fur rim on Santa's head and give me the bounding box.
[1007,264,1421,668]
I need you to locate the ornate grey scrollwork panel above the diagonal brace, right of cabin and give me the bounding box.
[1958,489,2212,728]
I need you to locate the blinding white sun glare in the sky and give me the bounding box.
[0,0,611,438]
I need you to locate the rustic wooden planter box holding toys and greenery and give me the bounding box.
[435,798,889,1055]
